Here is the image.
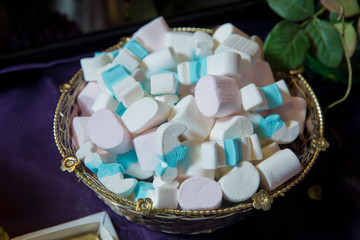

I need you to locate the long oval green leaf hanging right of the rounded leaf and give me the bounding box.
[305,18,344,68]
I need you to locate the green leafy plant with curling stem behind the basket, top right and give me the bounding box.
[264,0,360,108]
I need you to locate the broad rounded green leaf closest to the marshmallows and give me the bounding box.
[264,20,310,71]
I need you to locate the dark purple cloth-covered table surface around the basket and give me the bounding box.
[0,2,360,239]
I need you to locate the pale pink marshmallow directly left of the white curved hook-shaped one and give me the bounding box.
[133,128,160,171]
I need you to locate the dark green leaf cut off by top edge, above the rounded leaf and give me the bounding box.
[267,0,314,22]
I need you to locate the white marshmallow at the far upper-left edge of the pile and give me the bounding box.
[80,54,112,81]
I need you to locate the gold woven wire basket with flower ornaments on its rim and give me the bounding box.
[54,28,328,234]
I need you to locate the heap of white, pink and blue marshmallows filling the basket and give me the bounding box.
[72,17,306,210]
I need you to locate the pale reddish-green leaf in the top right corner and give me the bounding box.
[320,0,360,17]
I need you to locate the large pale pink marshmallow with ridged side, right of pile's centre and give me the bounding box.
[195,75,241,117]
